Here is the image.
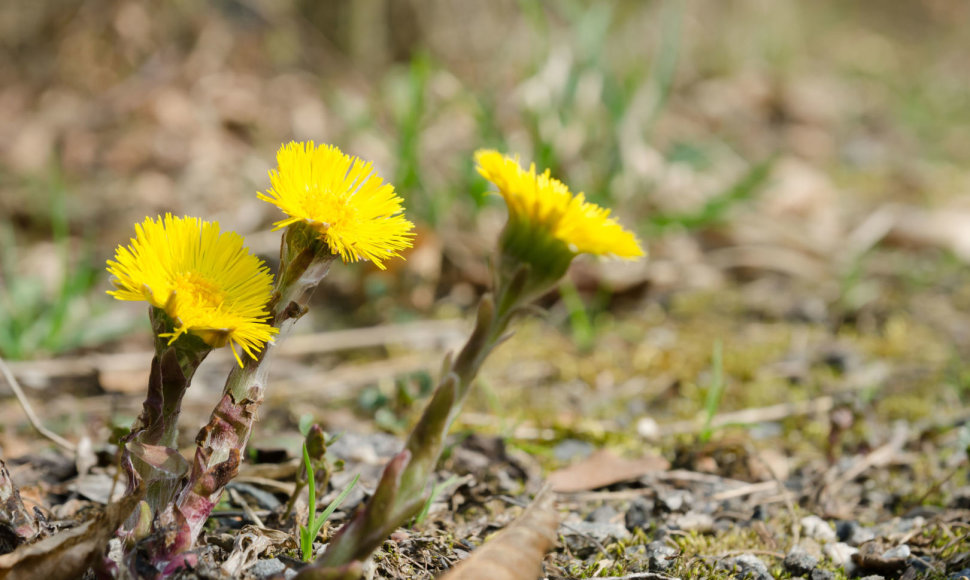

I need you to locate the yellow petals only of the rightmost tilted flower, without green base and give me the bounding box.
[475,150,644,259]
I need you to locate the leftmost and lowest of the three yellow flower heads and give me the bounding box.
[108,214,278,365]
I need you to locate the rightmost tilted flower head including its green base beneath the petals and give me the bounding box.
[475,150,644,282]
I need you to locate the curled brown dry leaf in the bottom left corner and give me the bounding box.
[0,488,144,580]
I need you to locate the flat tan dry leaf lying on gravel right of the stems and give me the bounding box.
[549,449,670,493]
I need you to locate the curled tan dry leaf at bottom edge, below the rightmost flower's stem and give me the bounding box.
[440,486,559,580]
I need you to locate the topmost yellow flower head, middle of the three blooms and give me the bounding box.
[258,141,414,270]
